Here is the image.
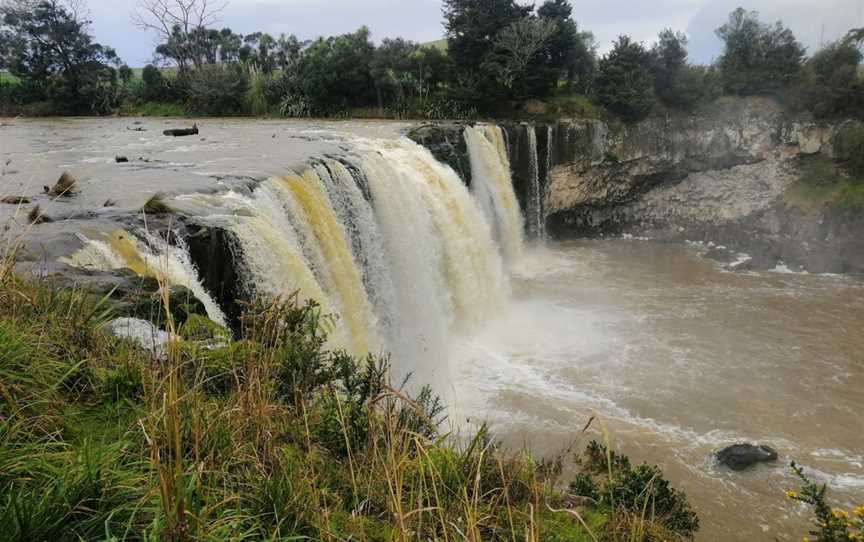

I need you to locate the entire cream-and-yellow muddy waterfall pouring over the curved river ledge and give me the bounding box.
[59,130,523,376]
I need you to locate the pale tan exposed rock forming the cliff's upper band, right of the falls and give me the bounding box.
[547,100,831,219]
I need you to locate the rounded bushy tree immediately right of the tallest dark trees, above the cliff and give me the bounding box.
[596,36,654,121]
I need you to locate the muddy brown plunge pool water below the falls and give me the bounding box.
[452,240,864,540]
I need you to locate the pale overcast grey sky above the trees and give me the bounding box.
[89,0,864,66]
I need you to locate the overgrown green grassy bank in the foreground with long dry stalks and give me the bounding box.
[0,239,698,542]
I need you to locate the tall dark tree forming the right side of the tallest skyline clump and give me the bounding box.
[537,0,597,94]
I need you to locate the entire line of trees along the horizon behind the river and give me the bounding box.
[0,0,864,121]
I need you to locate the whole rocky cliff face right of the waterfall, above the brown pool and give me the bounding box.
[416,98,864,272]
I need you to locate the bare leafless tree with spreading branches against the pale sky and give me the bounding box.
[132,0,228,71]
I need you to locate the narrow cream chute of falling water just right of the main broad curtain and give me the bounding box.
[465,125,524,261]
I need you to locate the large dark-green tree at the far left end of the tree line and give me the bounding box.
[0,0,121,113]
